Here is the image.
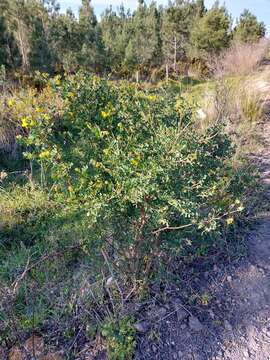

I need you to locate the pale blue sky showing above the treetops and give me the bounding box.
[58,0,270,34]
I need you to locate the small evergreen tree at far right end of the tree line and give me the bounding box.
[233,9,266,42]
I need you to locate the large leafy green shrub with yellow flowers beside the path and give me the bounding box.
[19,74,245,279]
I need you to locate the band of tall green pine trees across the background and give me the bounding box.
[0,0,265,81]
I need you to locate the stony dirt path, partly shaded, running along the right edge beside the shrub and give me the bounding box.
[137,69,270,360]
